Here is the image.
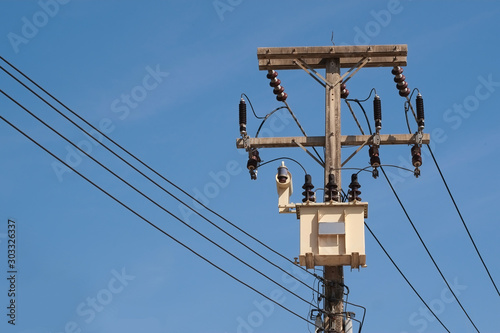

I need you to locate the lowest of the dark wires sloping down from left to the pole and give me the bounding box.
[0,116,312,324]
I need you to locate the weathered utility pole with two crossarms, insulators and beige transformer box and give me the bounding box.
[236,45,430,333]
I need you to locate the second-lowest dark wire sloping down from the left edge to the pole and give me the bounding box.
[0,89,320,303]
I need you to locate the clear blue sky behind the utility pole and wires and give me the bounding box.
[0,0,500,333]
